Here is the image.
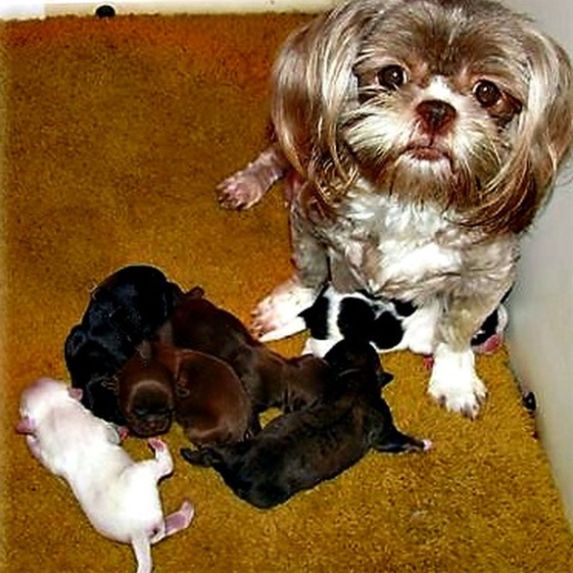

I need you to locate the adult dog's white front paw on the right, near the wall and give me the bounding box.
[428,344,487,419]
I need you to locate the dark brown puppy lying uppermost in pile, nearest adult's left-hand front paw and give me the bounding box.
[159,287,330,426]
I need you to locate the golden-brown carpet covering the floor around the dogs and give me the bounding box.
[0,15,573,573]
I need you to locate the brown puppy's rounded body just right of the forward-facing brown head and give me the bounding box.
[152,343,252,446]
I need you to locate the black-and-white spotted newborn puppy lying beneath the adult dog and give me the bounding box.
[298,284,507,356]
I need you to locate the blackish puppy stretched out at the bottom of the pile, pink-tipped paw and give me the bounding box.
[181,340,430,509]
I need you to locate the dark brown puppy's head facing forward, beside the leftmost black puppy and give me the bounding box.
[117,343,175,438]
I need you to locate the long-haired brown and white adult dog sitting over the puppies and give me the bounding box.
[219,0,573,417]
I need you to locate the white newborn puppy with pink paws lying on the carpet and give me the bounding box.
[17,378,193,573]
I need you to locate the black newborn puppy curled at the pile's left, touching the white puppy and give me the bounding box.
[64,265,181,425]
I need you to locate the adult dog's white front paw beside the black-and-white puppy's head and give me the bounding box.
[250,280,316,342]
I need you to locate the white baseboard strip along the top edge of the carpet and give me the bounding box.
[0,0,337,20]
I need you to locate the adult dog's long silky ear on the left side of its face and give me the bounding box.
[272,0,388,197]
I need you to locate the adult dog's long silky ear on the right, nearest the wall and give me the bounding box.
[468,19,573,233]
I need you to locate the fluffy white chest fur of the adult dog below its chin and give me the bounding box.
[326,193,468,300]
